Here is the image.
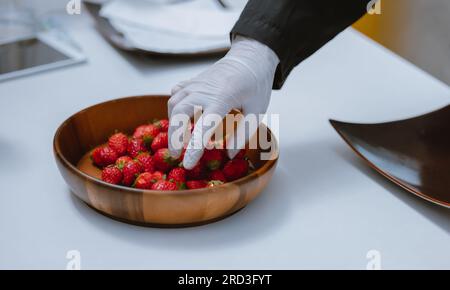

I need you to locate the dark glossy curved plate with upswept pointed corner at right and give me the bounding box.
[330,105,450,208]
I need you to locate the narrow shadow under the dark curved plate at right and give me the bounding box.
[336,147,450,233]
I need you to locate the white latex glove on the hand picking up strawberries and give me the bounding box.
[168,36,279,169]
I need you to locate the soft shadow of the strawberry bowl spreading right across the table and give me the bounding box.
[72,140,400,249]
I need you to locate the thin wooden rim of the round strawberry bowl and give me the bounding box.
[53,95,279,195]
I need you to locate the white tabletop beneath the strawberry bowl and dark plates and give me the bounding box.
[0,11,450,269]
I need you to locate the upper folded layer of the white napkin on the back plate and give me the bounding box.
[100,0,241,39]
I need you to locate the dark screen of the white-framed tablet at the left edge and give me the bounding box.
[0,38,68,74]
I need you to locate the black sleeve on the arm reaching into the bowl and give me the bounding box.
[232,0,370,89]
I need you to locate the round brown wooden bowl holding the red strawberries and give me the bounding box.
[53,96,278,227]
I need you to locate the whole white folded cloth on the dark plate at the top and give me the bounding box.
[100,0,245,53]
